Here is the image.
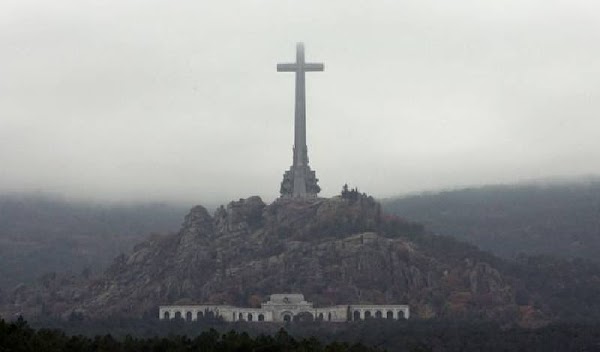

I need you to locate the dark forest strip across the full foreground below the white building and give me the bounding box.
[0,319,600,352]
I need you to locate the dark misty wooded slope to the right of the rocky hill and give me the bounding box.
[382,179,600,260]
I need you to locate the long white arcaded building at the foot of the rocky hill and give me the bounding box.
[158,293,410,322]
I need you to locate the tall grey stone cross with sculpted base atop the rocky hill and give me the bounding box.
[277,43,323,198]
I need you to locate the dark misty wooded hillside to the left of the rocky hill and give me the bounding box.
[0,195,188,290]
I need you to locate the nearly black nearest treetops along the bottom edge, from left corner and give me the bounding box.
[0,318,381,352]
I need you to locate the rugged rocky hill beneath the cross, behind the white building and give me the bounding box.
[3,195,551,324]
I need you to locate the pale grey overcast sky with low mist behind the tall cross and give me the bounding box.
[0,0,600,202]
